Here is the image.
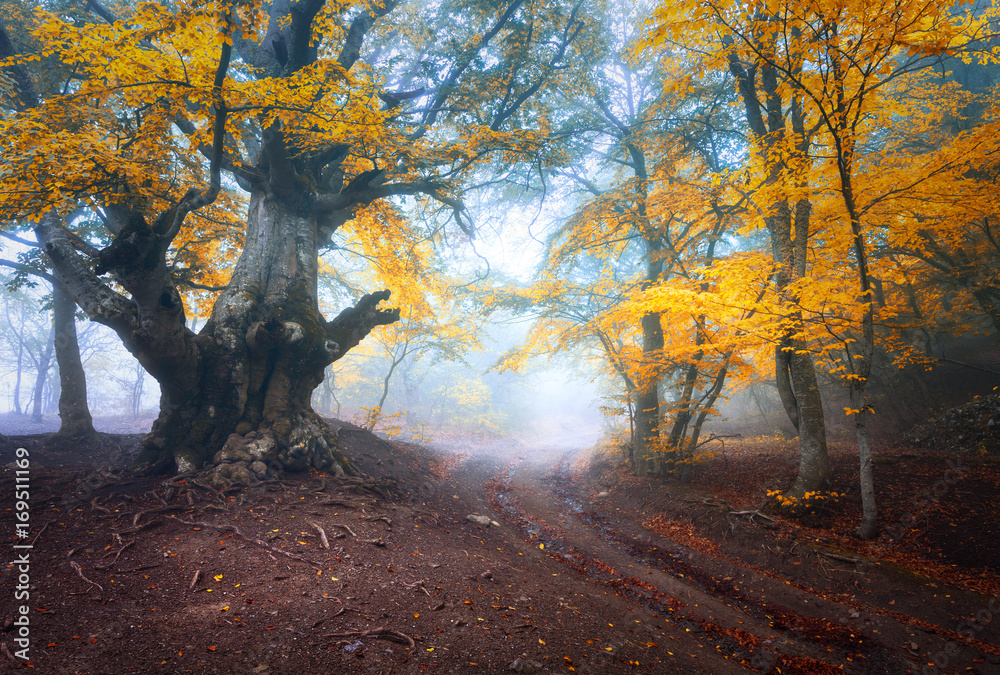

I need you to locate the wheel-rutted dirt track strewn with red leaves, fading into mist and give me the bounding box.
[486,447,968,673]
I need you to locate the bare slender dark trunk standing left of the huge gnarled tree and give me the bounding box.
[52,281,97,439]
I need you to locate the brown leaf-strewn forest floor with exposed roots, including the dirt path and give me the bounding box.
[0,425,1000,675]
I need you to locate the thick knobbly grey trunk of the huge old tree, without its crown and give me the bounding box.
[132,191,398,478]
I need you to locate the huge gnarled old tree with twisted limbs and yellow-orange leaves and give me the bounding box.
[0,0,586,472]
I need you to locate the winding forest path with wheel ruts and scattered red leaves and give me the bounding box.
[450,433,977,673]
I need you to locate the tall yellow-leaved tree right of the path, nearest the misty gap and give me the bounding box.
[484,3,741,476]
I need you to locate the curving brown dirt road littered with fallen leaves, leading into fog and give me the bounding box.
[452,438,1000,673]
